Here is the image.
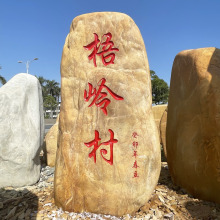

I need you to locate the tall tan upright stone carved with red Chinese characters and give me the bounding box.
[54,12,160,216]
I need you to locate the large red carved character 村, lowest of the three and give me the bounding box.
[85,129,118,165]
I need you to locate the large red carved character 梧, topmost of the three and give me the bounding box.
[83,33,119,67]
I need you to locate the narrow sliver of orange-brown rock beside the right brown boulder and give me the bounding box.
[159,108,168,157]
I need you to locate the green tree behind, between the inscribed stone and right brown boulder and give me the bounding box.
[150,70,169,105]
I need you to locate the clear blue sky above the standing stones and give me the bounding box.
[0,0,220,84]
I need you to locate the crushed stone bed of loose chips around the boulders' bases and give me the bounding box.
[0,162,220,220]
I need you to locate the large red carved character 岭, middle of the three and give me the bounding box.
[84,78,124,115]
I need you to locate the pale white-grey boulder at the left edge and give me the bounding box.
[0,73,44,187]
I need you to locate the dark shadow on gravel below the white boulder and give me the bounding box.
[0,187,38,220]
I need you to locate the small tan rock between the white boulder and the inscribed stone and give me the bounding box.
[45,116,59,167]
